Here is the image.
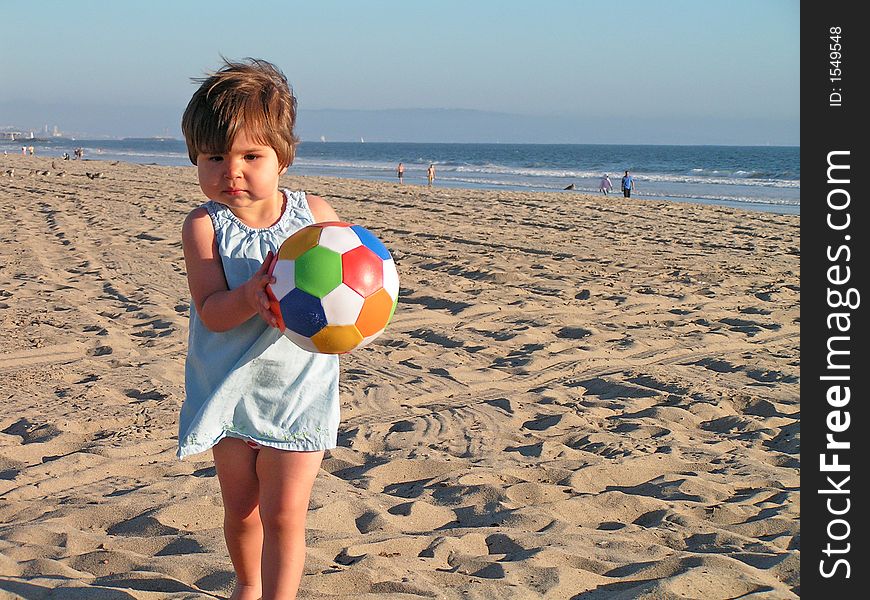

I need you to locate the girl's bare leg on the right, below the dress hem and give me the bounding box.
[257,448,323,600]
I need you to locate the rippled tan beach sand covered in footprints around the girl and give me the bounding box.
[0,156,800,600]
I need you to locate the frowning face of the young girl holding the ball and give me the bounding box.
[196,130,287,209]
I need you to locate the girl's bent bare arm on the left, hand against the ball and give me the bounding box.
[181,208,277,332]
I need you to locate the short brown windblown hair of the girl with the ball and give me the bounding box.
[181,58,299,167]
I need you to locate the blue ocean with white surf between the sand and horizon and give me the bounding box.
[0,138,800,214]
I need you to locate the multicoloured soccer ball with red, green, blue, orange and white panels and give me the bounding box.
[266,221,399,354]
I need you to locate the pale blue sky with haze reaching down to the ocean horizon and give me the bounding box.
[0,0,800,145]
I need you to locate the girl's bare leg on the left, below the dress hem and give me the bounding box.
[212,438,263,600]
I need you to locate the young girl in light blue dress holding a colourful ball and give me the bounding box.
[178,59,339,600]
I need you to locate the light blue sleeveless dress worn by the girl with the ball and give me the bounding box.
[177,189,339,459]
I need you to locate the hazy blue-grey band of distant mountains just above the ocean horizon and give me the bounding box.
[0,101,800,146]
